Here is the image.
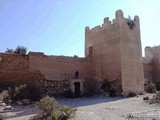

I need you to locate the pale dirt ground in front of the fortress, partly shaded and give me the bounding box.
[0,94,160,120]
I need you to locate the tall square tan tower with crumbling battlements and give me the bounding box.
[85,10,144,94]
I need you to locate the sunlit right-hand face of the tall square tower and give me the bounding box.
[118,13,144,93]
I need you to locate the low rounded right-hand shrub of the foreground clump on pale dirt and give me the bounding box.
[52,105,76,120]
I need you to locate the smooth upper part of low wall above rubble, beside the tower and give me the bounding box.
[29,53,90,80]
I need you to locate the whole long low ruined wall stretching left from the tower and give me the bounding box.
[0,52,91,94]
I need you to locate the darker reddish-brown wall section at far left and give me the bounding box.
[0,53,29,85]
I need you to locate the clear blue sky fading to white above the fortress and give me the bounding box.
[0,0,160,56]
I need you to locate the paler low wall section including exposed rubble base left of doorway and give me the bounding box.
[29,52,91,94]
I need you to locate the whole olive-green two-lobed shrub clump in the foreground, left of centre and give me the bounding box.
[30,96,75,120]
